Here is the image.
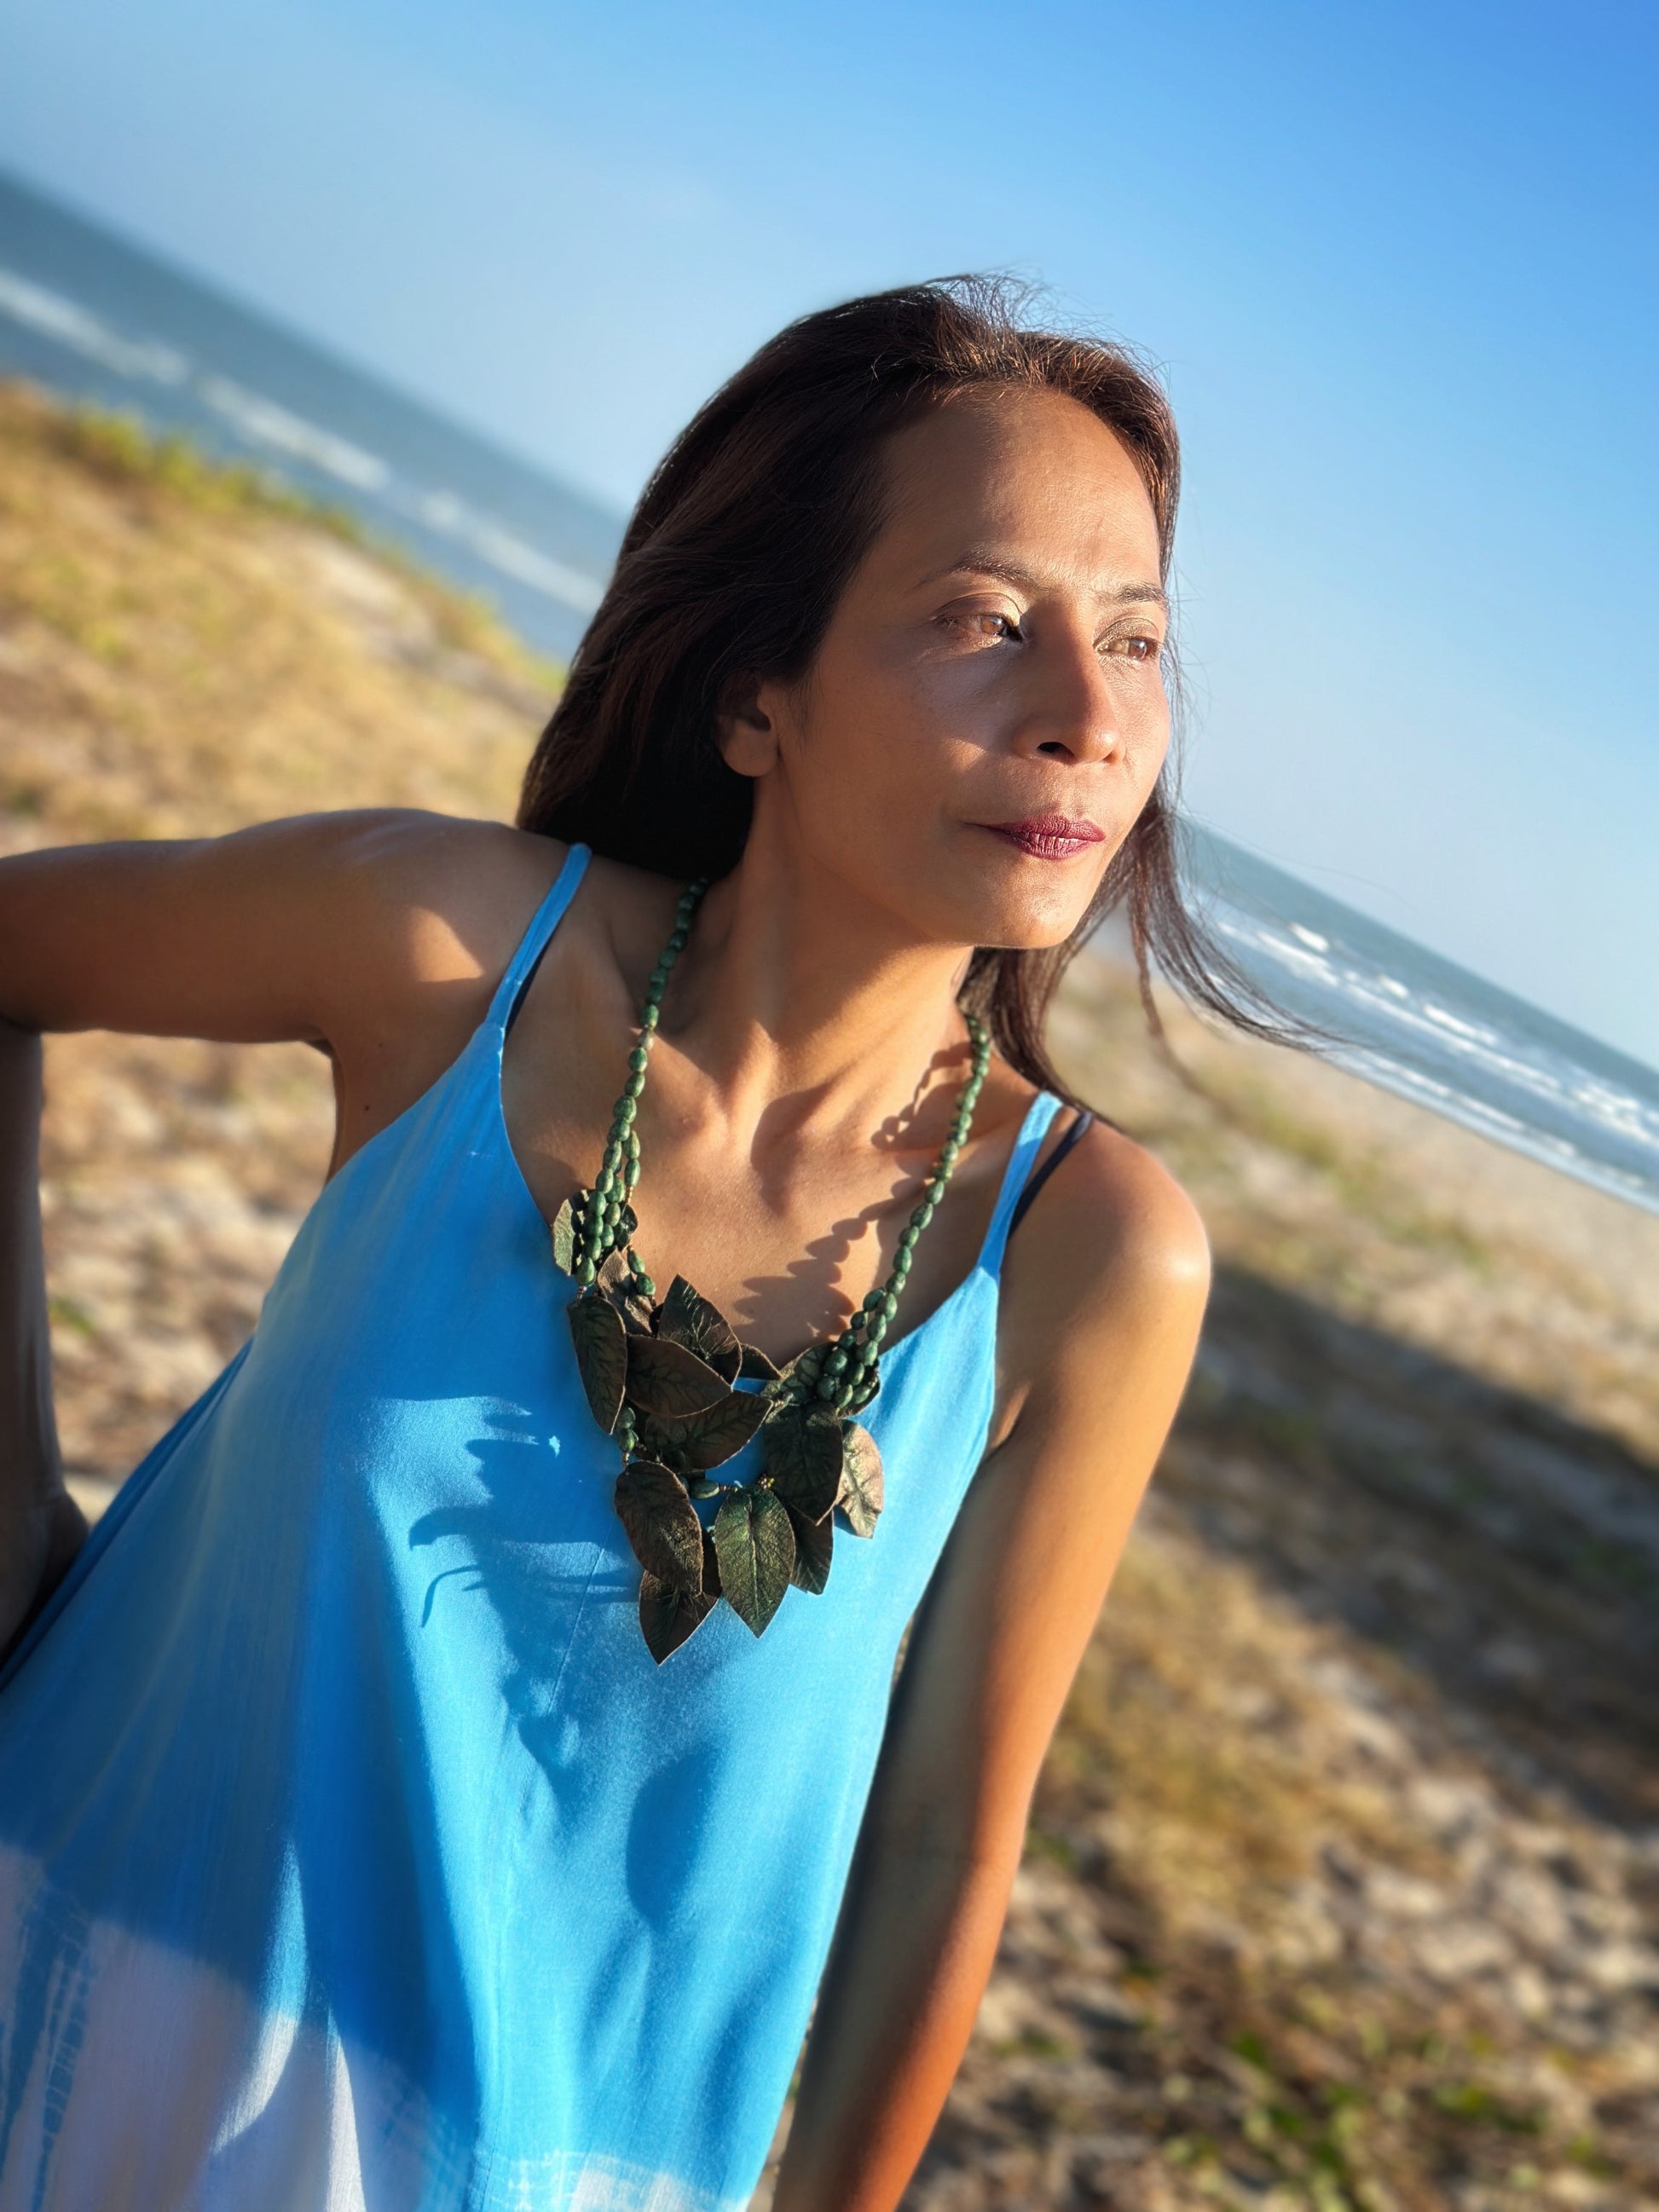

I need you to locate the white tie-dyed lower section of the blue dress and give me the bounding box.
[0,1847,743,2212]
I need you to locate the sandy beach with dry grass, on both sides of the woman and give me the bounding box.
[0,390,1659,2212]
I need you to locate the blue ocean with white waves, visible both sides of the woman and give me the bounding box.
[0,164,1659,1212]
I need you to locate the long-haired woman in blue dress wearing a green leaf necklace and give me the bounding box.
[0,283,1250,2212]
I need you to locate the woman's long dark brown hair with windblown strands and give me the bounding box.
[517,276,1294,1095]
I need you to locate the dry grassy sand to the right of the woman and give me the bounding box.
[907,960,1659,2212]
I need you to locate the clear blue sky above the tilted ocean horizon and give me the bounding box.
[0,0,1659,1064]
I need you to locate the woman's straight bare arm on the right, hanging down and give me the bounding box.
[774,1128,1210,2212]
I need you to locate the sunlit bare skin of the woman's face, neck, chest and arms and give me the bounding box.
[0,391,1208,2212]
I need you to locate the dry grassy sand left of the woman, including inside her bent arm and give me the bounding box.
[0,387,540,1495]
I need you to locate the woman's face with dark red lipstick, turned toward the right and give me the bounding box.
[723,390,1171,947]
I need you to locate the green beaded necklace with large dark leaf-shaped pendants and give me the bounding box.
[553,878,991,1666]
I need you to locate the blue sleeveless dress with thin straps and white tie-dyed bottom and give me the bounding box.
[0,847,1057,2212]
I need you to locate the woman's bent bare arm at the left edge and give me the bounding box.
[0,811,562,1657]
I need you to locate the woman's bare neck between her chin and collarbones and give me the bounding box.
[663,839,971,1144]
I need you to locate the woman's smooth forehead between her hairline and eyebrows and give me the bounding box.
[870,387,1159,580]
